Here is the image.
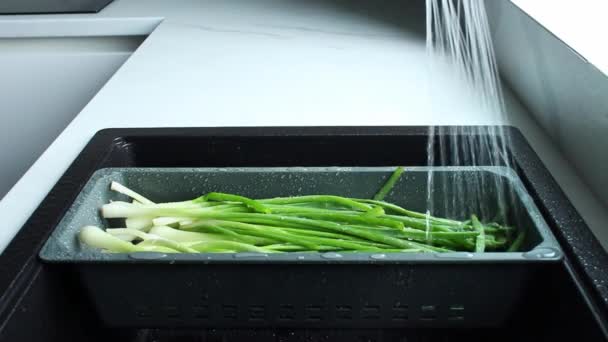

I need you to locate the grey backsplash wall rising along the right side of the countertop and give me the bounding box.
[486,0,608,208]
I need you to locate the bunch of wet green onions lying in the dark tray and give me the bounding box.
[79,176,525,253]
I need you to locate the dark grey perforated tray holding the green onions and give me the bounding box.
[40,166,562,327]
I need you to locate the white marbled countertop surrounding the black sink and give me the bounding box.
[0,0,607,254]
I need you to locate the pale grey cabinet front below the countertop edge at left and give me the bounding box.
[0,37,142,198]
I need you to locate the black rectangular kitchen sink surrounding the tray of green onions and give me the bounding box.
[0,127,608,342]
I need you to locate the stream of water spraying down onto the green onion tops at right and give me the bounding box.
[426,0,514,235]
